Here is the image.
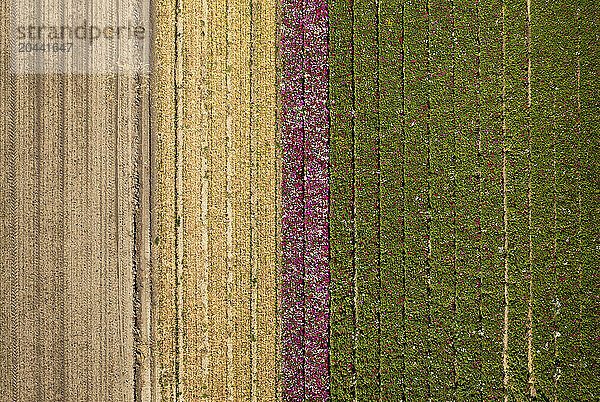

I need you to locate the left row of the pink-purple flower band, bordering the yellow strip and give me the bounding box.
[280,0,305,400]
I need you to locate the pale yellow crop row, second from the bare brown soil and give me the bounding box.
[179,0,210,400]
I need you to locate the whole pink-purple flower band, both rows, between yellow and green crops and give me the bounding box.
[280,0,329,401]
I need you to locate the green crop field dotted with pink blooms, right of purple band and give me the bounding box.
[329,0,600,401]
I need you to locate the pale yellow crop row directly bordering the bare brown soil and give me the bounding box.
[150,0,178,401]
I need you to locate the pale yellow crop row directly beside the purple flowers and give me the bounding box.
[252,0,280,401]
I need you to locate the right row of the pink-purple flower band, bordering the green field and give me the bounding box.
[304,0,329,401]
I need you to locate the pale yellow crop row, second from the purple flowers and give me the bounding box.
[226,0,253,401]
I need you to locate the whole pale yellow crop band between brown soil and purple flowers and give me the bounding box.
[151,0,280,401]
